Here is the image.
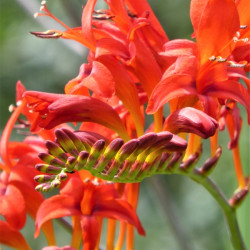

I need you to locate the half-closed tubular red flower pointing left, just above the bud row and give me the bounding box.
[24,91,128,139]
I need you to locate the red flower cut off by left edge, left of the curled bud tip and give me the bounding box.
[0,138,55,249]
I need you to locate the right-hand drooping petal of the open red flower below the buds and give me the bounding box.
[92,199,145,235]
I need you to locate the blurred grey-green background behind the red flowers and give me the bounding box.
[0,0,250,250]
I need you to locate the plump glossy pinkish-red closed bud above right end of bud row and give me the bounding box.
[164,107,218,139]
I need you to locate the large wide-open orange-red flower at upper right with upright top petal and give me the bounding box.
[147,0,250,123]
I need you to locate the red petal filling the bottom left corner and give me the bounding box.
[0,220,31,250]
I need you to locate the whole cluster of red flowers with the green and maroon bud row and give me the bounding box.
[0,0,250,250]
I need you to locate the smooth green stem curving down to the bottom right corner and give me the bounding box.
[177,169,246,250]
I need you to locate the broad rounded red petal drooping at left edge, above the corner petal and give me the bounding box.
[0,185,26,230]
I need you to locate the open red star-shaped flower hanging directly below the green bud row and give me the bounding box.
[35,177,145,249]
